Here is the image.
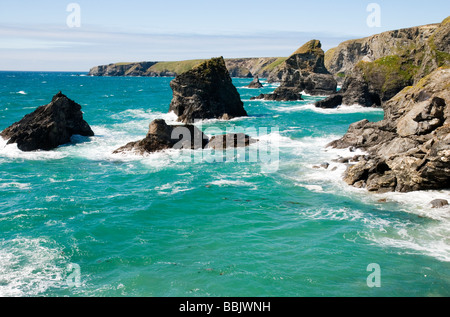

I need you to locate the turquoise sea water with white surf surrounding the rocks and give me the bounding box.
[0,72,450,297]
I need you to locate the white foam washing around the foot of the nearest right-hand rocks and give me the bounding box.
[282,131,450,262]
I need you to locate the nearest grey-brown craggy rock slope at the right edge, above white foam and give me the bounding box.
[330,68,450,192]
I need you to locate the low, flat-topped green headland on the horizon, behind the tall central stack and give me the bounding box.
[89,57,286,78]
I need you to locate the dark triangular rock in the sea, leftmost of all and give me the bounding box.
[0,92,94,151]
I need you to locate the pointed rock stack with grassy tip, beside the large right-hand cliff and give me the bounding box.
[260,40,337,101]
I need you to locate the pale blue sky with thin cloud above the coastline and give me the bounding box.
[0,0,450,72]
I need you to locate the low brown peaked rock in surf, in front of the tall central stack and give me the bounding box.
[113,119,208,155]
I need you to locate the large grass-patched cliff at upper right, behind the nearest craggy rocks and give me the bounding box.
[316,18,450,108]
